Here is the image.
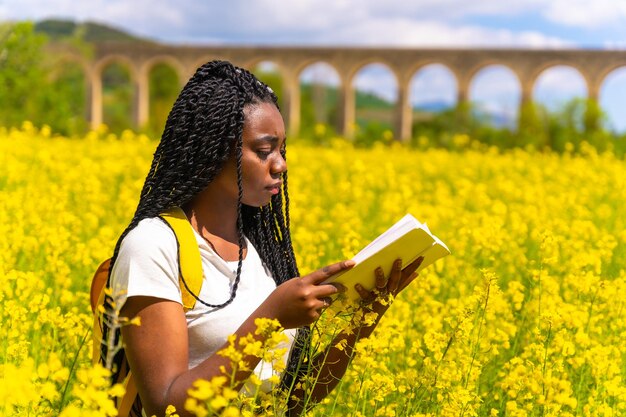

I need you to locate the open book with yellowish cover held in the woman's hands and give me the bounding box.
[324,214,450,301]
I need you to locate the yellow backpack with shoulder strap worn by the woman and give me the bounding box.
[90,207,203,417]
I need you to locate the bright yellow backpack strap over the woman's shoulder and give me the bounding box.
[159,207,204,310]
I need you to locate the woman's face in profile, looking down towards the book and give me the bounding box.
[213,103,287,207]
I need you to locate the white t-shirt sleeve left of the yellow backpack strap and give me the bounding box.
[111,218,182,304]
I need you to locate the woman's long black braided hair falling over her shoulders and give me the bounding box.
[101,61,308,394]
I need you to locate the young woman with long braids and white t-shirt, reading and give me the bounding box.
[109,61,419,415]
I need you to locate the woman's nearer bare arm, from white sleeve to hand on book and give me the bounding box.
[121,261,354,416]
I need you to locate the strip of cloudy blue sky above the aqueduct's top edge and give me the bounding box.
[0,0,626,48]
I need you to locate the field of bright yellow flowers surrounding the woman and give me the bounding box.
[0,124,626,417]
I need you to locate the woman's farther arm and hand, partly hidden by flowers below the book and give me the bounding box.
[289,257,424,415]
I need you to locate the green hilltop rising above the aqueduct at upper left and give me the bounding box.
[35,19,153,43]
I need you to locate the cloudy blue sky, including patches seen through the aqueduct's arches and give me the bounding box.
[0,0,626,130]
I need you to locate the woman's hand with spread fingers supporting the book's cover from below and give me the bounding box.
[354,256,424,312]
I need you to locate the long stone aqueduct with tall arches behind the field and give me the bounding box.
[50,42,626,140]
